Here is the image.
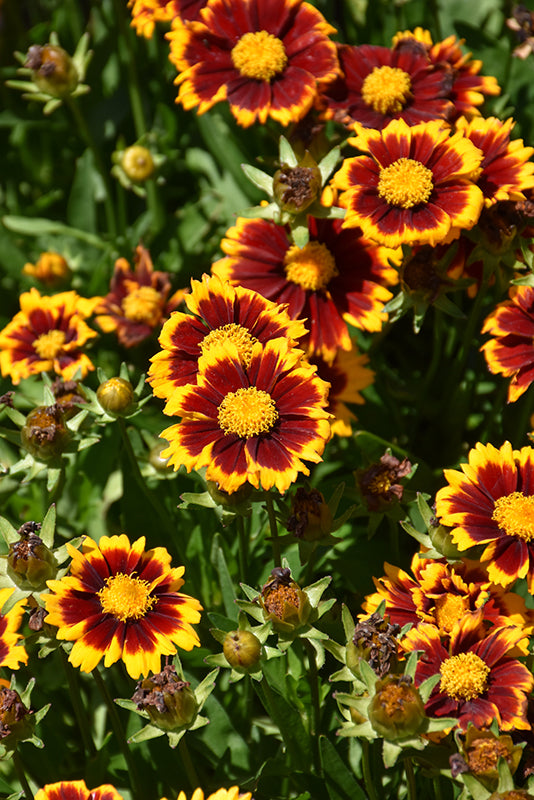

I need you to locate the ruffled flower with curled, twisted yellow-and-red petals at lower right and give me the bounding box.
[362,553,533,638]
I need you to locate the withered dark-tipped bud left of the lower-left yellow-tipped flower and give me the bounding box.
[7,522,58,590]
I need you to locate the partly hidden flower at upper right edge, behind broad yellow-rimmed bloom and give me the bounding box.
[456,117,534,206]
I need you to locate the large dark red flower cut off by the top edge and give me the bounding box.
[167,0,339,127]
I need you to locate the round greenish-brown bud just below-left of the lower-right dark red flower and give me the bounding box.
[368,675,426,740]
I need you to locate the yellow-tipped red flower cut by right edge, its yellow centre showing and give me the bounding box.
[436,442,534,592]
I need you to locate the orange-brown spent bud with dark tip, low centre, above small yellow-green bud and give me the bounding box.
[260,567,311,632]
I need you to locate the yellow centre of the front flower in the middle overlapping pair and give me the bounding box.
[217,386,278,439]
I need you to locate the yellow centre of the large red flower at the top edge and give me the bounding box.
[232,31,287,81]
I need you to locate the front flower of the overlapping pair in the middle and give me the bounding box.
[161,339,330,493]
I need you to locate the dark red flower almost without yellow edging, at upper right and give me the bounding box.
[320,44,454,130]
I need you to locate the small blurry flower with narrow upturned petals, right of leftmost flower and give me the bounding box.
[95,244,185,347]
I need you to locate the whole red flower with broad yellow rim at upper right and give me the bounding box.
[333,119,483,247]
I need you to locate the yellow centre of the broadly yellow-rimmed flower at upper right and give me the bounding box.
[378,158,434,208]
